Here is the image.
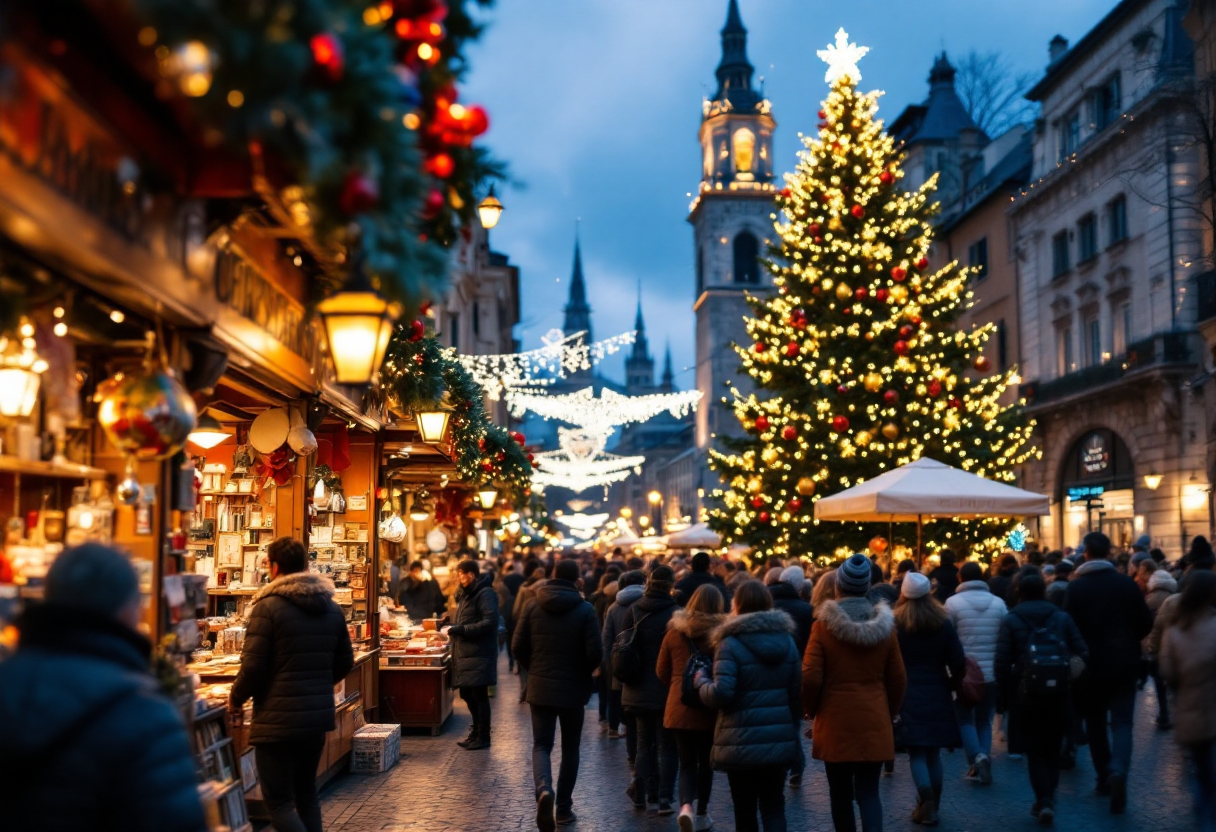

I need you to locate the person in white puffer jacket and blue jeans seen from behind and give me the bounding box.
[946,561,1008,785]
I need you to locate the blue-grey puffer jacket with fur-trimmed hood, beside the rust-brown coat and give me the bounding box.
[700,609,803,771]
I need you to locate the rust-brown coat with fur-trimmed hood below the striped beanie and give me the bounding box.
[803,597,907,763]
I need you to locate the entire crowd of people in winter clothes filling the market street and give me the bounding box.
[0,533,1216,832]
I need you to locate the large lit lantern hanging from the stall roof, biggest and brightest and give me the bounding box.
[316,243,400,384]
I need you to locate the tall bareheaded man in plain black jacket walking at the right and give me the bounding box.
[1064,532,1153,815]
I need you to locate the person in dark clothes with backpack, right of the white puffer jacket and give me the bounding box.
[992,574,1090,826]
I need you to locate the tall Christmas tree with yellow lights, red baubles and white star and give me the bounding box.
[710,29,1035,562]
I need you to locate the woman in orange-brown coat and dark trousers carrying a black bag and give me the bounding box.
[657,584,726,832]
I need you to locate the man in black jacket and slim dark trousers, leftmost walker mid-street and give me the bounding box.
[512,561,603,832]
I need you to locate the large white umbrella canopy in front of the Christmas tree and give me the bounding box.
[815,459,1051,523]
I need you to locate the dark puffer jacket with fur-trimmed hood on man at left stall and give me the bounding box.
[231,572,354,746]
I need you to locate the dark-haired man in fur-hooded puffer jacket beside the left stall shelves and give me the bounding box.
[229,538,354,832]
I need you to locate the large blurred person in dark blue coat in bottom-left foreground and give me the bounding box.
[0,544,204,832]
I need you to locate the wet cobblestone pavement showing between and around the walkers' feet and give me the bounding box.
[322,660,1194,832]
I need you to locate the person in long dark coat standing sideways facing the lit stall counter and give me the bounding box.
[447,561,499,751]
